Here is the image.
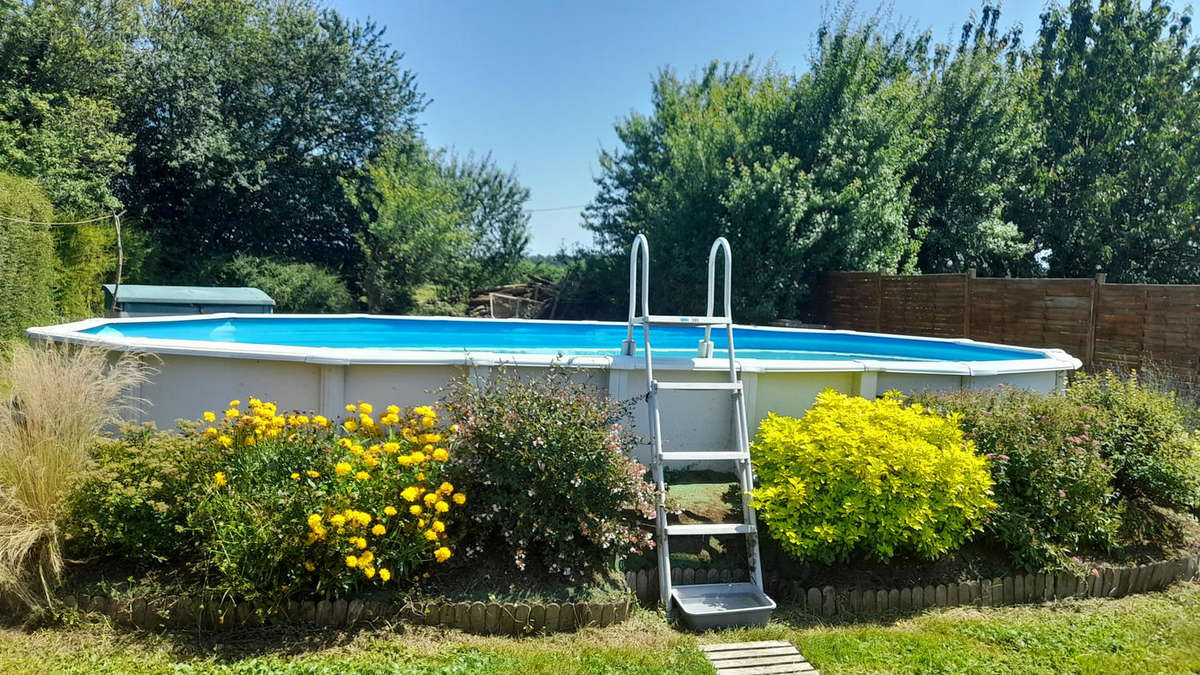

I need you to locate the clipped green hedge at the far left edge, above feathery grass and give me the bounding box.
[0,173,58,340]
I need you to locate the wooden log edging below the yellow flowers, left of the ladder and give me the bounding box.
[61,595,636,635]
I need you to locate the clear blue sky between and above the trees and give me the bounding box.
[330,0,1044,253]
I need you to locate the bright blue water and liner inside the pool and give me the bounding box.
[84,316,1043,362]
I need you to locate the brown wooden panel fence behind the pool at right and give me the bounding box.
[815,270,1200,382]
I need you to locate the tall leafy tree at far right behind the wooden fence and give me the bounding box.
[1016,0,1200,278]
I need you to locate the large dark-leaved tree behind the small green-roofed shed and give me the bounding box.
[124,0,425,279]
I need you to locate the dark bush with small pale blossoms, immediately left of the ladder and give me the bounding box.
[446,370,654,579]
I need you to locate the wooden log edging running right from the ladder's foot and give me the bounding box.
[625,554,1200,617]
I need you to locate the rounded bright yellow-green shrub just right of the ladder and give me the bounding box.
[752,389,995,563]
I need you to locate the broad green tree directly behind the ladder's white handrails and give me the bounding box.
[586,17,925,321]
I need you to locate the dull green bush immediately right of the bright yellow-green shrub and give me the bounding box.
[917,388,1120,571]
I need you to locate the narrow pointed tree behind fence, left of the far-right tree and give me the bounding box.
[910,5,1038,276]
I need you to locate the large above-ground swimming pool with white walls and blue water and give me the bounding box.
[28,313,1080,459]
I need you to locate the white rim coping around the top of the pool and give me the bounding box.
[25,312,1082,377]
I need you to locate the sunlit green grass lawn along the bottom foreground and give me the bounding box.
[0,584,1200,675]
